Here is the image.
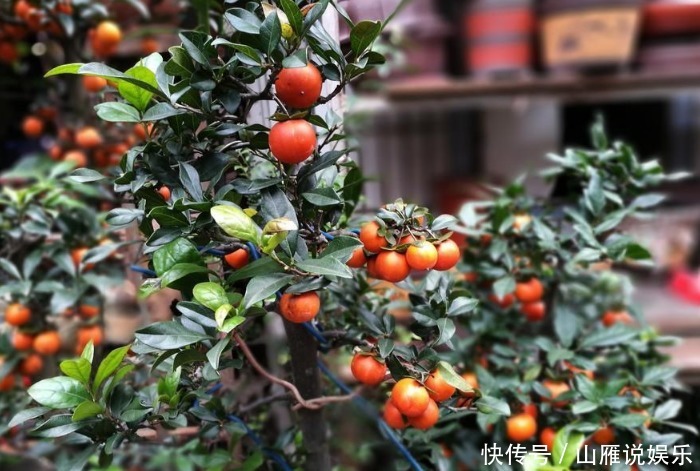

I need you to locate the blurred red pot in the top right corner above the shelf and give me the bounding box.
[642,0,700,36]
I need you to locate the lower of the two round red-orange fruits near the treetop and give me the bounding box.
[270,119,316,164]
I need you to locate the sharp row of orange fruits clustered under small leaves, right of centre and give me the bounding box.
[347,220,461,283]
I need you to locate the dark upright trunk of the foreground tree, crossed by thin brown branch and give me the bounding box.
[284,321,331,471]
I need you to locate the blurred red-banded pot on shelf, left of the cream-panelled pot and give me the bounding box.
[462,0,536,75]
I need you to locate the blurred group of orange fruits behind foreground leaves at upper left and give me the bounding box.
[22,109,153,168]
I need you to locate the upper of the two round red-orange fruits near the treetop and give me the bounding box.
[275,63,323,108]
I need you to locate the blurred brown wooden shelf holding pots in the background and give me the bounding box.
[386,68,700,104]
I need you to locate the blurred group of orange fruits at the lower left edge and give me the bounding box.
[0,303,102,391]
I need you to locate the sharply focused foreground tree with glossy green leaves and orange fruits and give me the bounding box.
[12,0,692,470]
